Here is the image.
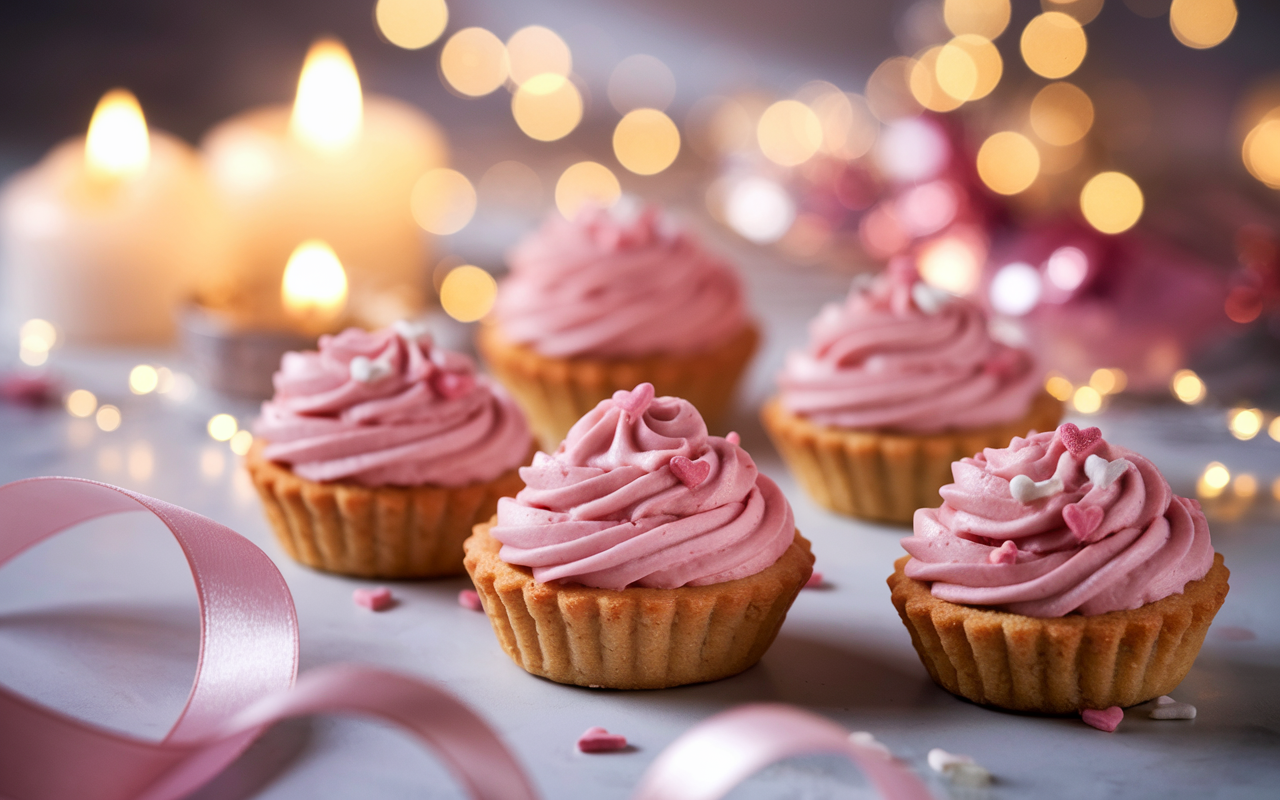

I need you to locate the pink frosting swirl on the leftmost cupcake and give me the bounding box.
[253,324,532,486]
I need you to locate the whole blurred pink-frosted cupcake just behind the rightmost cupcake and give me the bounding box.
[762,261,1062,525]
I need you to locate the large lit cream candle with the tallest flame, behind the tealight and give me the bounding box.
[202,40,445,318]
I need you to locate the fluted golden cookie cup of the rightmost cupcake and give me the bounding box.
[888,554,1230,714]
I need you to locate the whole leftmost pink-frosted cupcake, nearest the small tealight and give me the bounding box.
[246,323,532,579]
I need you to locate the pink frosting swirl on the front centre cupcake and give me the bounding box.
[492,384,795,589]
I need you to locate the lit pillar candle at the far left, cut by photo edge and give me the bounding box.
[0,90,225,343]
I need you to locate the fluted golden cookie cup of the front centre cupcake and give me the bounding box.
[465,521,813,689]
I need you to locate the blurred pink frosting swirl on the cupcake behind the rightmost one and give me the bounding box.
[778,262,1039,434]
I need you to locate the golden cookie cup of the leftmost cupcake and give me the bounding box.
[244,443,531,579]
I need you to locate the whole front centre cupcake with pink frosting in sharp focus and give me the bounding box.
[466,384,813,689]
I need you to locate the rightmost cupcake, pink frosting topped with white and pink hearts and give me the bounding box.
[888,424,1229,713]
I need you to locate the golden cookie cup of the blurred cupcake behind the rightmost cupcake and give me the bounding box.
[760,393,1062,525]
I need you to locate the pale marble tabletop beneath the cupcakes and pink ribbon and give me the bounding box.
[0,248,1280,800]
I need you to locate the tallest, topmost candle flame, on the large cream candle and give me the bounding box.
[289,38,364,154]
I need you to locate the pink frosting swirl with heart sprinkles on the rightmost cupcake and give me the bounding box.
[902,422,1213,617]
